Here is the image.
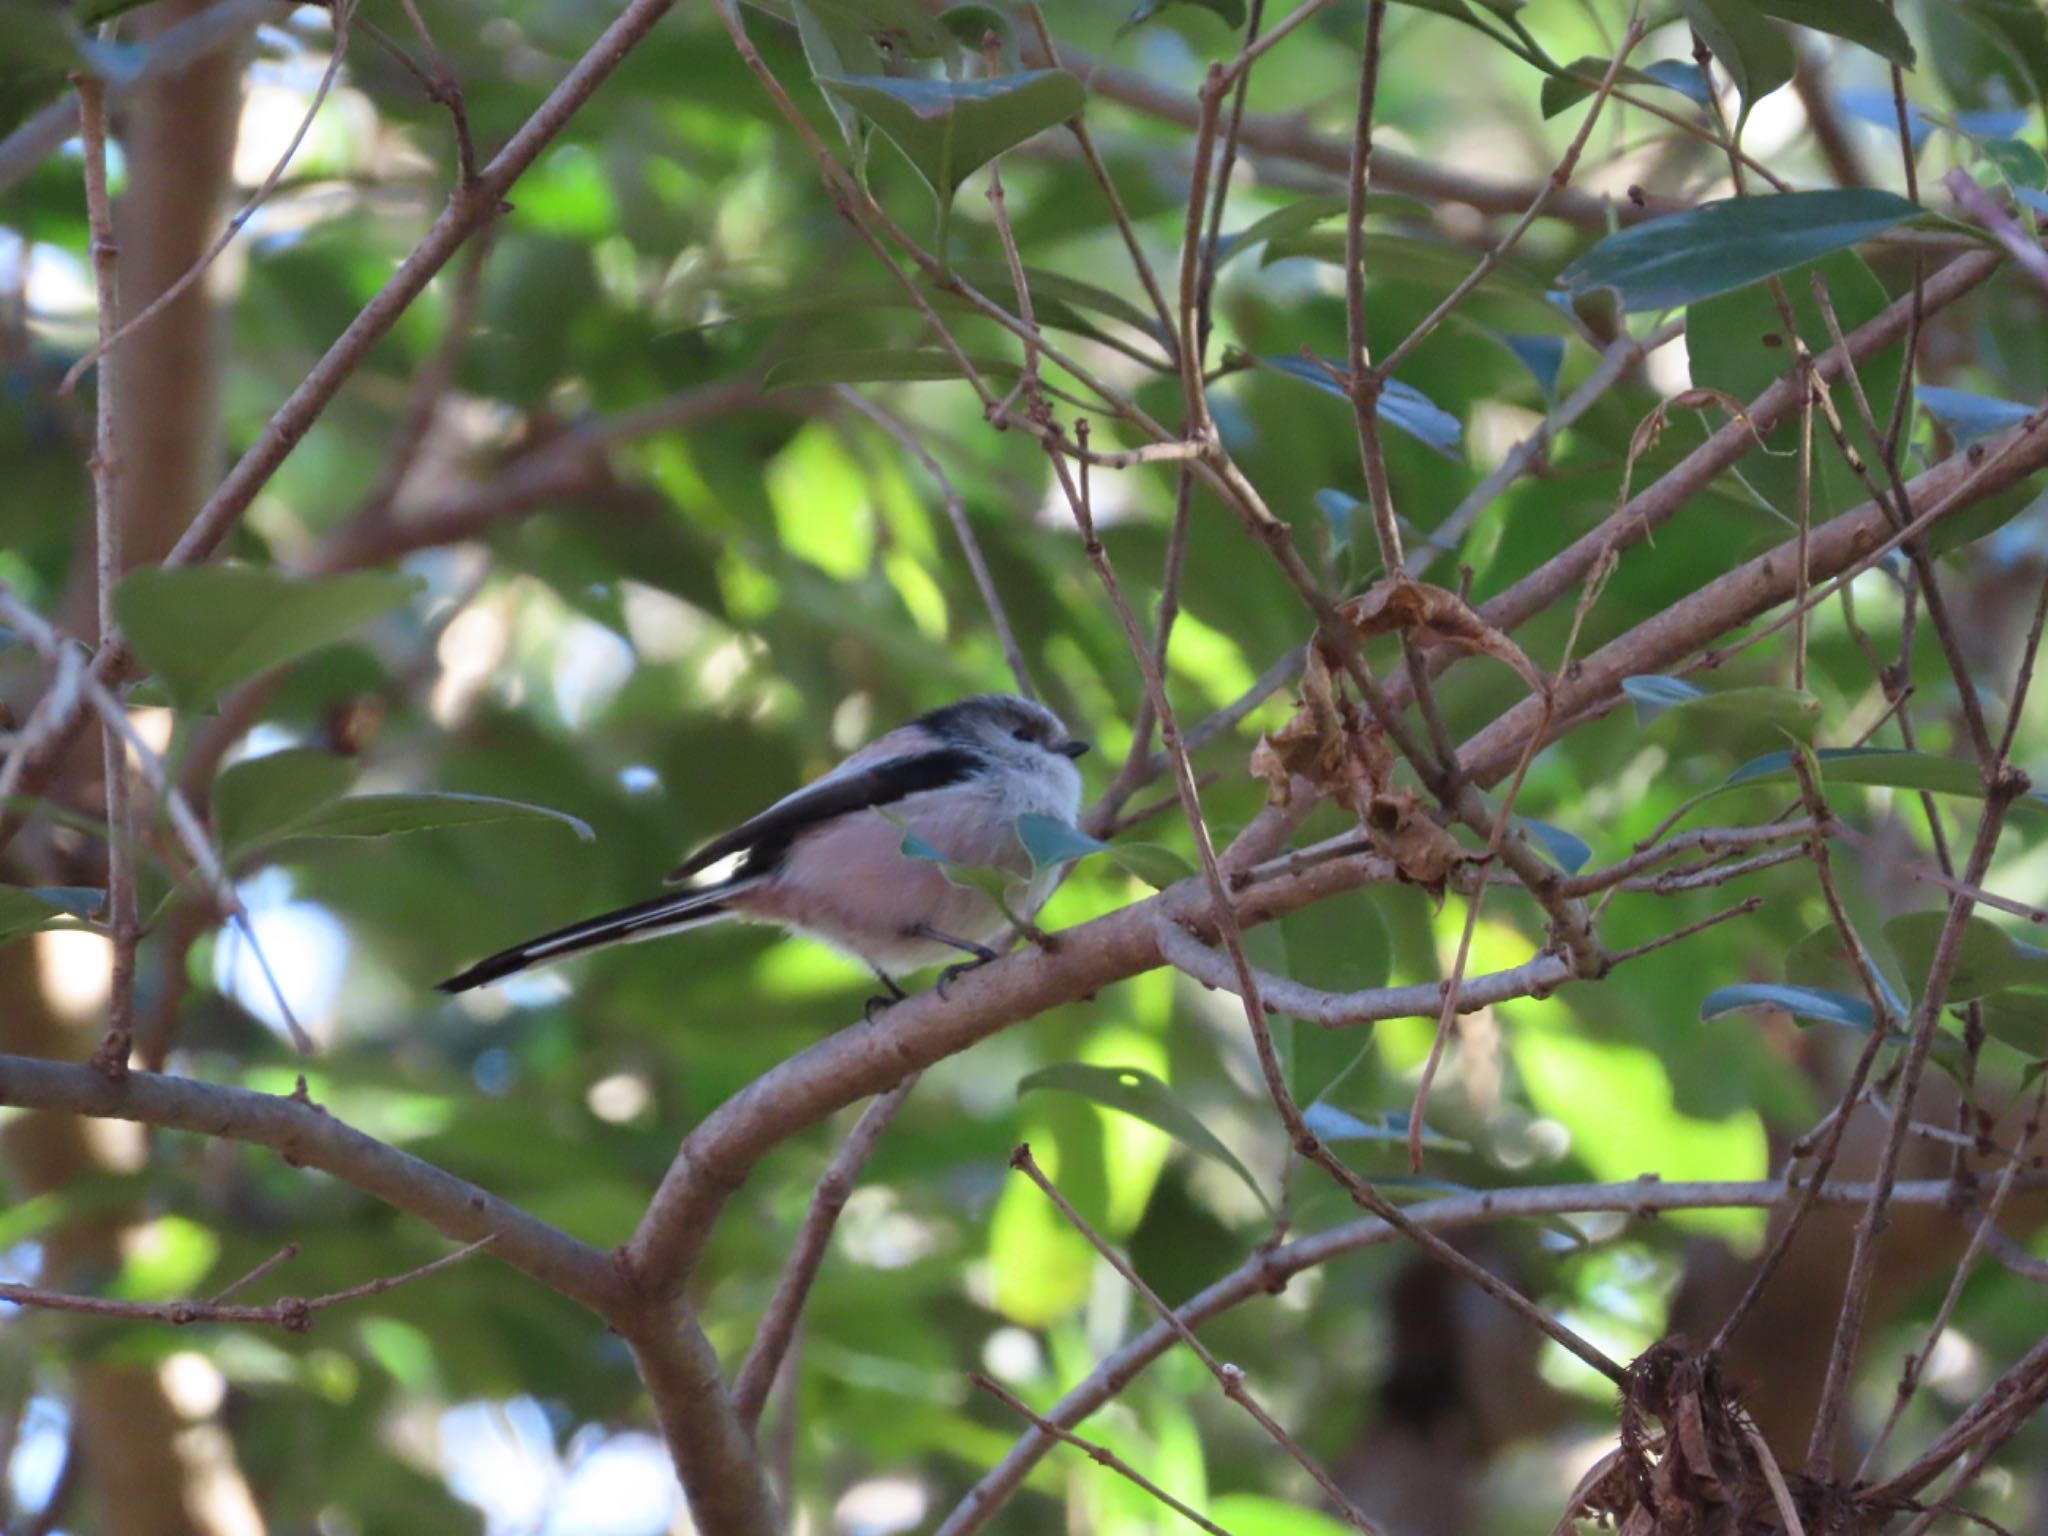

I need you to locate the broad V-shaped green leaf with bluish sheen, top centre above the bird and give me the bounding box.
[817,70,1087,203]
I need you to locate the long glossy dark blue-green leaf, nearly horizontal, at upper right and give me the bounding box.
[1559,186,1921,309]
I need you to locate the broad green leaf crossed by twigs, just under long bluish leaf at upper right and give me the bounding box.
[1686,250,1903,522]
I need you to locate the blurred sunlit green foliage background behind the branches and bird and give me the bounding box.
[0,0,2048,1536]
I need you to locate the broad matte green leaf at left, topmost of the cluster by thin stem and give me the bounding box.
[115,565,422,709]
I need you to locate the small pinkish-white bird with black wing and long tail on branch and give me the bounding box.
[440,694,1087,1012]
